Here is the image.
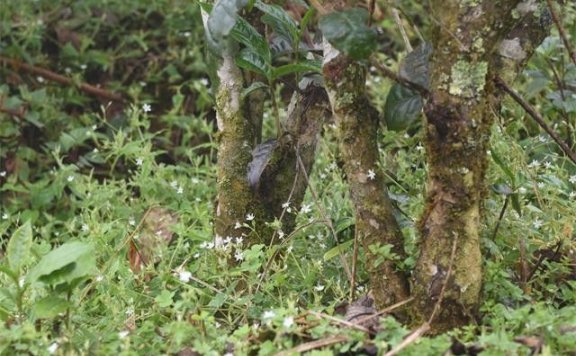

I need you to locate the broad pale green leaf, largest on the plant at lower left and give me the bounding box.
[27,241,96,286]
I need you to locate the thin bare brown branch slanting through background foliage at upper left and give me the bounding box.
[0,56,124,102]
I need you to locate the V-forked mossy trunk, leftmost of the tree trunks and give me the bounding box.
[203,9,330,245]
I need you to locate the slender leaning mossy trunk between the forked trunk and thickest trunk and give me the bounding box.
[323,43,409,307]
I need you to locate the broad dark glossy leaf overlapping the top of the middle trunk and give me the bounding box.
[320,8,376,59]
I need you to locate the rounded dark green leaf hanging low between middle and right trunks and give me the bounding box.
[384,83,424,131]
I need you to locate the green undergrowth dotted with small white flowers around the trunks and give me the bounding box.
[0,0,576,355]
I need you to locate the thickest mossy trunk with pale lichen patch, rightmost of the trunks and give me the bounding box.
[412,0,545,332]
